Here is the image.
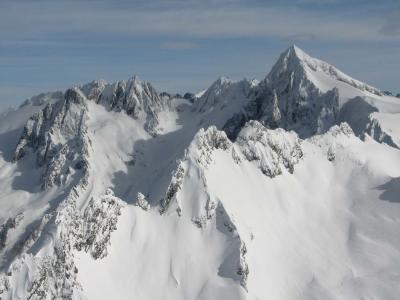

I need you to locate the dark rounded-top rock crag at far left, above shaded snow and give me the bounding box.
[13,89,90,189]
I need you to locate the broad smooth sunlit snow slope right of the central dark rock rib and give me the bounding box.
[187,123,400,299]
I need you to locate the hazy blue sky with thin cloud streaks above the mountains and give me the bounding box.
[0,0,400,108]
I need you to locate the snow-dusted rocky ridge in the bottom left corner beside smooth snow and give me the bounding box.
[0,189,125,299]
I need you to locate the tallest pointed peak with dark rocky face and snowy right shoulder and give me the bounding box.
[223,46,393,145]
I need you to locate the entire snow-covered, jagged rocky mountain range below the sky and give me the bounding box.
[0,46,400,299]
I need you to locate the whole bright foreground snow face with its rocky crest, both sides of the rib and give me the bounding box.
[76,122,400,299]
